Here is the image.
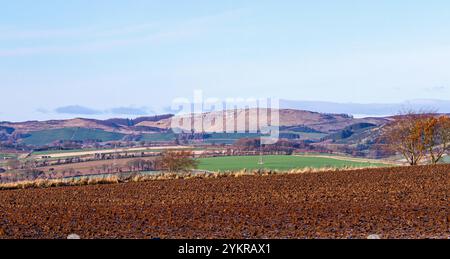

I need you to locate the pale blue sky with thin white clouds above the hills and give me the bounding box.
[0,0,450,121]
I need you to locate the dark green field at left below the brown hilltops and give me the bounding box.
[23,128,124,146]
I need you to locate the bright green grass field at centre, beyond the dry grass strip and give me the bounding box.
[199,156,386,171]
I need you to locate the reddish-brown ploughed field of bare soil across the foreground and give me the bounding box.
[0,165,450,238]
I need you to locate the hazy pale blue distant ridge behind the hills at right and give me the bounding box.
[280,99,450,117]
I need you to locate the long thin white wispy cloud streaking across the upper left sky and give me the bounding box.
[0,9,243,57]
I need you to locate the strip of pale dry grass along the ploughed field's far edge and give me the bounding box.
[0,167,386,190]
